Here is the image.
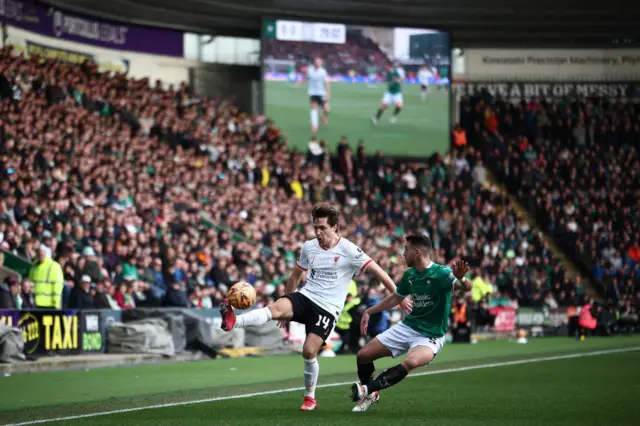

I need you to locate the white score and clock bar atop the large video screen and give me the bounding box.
[263,19,347,44]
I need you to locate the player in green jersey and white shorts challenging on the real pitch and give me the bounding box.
[351,235,471,412]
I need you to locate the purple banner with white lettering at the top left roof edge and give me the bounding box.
[0,0,184,57]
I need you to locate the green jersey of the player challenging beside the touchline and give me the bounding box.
[396,263,456,338]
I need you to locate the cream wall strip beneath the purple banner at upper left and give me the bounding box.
[5,25,194,85]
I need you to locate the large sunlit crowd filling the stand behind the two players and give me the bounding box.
[0,48,582,346]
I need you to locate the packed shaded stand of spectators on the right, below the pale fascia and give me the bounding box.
[461,93,640,322]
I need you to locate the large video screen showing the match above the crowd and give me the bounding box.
[262,20,451,157]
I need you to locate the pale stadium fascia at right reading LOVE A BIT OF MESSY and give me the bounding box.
[451,49,640,122]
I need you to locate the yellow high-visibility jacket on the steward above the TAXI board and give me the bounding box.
[29,257,64,309]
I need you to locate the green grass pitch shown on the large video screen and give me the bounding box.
[264,81,450,157]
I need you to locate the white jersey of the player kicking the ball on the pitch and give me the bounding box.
[296,238,373,319]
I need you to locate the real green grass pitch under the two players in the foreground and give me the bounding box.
[0,337,640,426]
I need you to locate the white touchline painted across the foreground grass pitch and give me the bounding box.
[4,346,640,426]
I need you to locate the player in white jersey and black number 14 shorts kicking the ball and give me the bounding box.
[220,204,412,411]
